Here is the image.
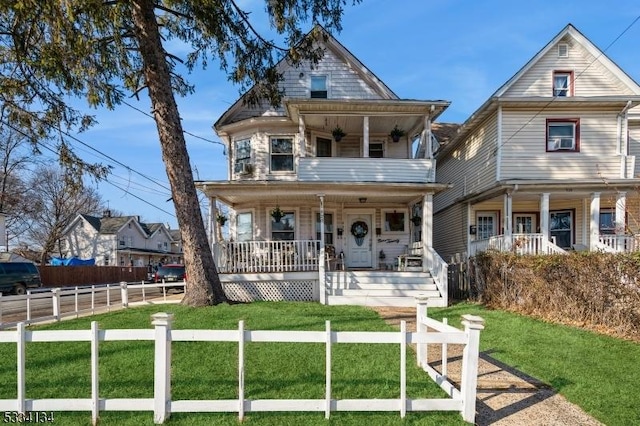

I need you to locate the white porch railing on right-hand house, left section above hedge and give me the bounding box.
[469,234,566,256]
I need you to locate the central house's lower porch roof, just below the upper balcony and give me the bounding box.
[195,181,451,206]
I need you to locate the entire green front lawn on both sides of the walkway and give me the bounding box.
[0,303,640,426]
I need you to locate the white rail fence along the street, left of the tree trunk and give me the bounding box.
[0,281,185,329]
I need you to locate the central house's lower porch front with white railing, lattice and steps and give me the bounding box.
[213,240,448,306]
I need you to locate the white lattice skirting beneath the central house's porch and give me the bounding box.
[223,280,318,302]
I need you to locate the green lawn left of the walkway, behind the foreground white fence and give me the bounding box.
[0,303,464,425]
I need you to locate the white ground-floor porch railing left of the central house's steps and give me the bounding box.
[213,240,320,273]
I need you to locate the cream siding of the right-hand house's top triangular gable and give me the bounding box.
[503,36,633,97]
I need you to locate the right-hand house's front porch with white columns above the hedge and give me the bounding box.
[468,185,640,256]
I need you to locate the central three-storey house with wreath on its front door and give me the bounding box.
[196,28,449,305]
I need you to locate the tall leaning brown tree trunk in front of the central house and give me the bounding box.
[133,0,227,306]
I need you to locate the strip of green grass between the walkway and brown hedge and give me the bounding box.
[429,303,640,426]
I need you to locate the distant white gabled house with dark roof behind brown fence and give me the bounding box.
[60,210,182,266]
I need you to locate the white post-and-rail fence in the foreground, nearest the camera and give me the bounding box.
[0,299,483,424]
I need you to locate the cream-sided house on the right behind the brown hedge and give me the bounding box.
[434,25,640,260]
